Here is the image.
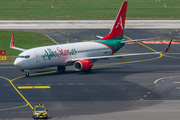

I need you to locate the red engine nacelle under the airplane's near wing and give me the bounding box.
[74,60,93,71]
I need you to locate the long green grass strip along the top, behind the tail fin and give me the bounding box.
[0,0,180,20]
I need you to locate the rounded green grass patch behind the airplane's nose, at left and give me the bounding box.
[0,30,55,63]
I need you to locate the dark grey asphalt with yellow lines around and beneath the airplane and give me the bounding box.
[0,29,180,120]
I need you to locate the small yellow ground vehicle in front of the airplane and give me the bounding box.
[33,104,48,119]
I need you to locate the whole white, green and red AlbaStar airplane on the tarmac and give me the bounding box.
[10,1,173,77]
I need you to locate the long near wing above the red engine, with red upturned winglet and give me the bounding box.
[68,39,173,62]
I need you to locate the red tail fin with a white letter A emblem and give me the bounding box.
[101,1,128,40]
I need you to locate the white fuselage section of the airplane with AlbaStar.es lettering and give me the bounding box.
[14,42,113,70]
